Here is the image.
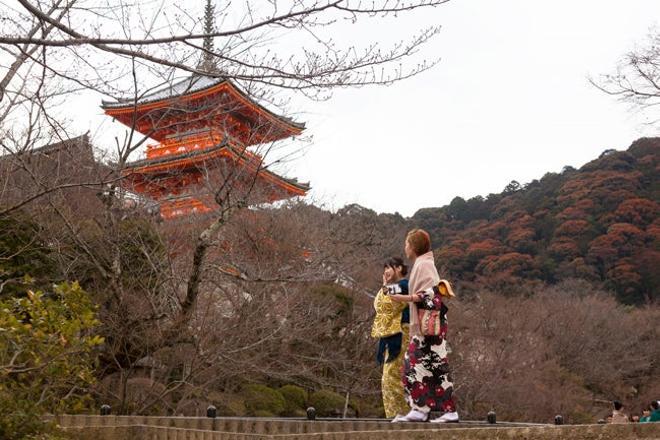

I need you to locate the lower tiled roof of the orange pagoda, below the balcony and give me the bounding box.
[124,138,310,195]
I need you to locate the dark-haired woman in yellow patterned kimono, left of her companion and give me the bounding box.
[371,258,410,418]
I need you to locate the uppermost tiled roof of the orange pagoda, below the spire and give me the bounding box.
[101,74,305,130]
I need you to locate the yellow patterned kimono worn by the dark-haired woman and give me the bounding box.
[371,280,410,418]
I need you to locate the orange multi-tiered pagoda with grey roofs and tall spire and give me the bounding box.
[102,3,309,219]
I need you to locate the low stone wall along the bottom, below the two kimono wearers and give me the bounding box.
[58,416,660,440]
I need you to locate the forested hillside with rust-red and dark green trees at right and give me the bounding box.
[412,138,660,304]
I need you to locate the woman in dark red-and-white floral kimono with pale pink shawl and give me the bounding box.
[391,229,458,423]
